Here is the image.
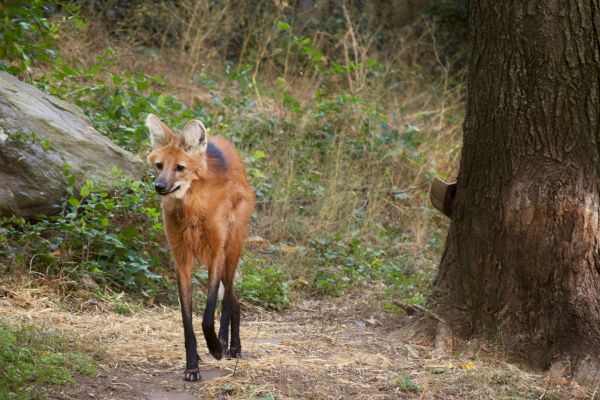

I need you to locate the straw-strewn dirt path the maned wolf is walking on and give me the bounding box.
[0,289,580,400]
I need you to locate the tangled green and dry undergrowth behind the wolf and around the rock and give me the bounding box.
[0,1,462,311]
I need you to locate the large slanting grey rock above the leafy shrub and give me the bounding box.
[0,72,143,217]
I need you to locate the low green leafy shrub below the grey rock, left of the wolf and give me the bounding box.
[0,167,170,297]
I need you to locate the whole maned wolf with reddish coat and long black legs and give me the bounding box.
[146,114,255,381]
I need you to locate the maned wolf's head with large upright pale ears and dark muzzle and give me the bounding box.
[146,114,208,199]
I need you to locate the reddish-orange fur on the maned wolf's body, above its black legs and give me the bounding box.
[148,137,254,278]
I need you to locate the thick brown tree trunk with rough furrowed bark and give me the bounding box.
[435,0,600,381]
